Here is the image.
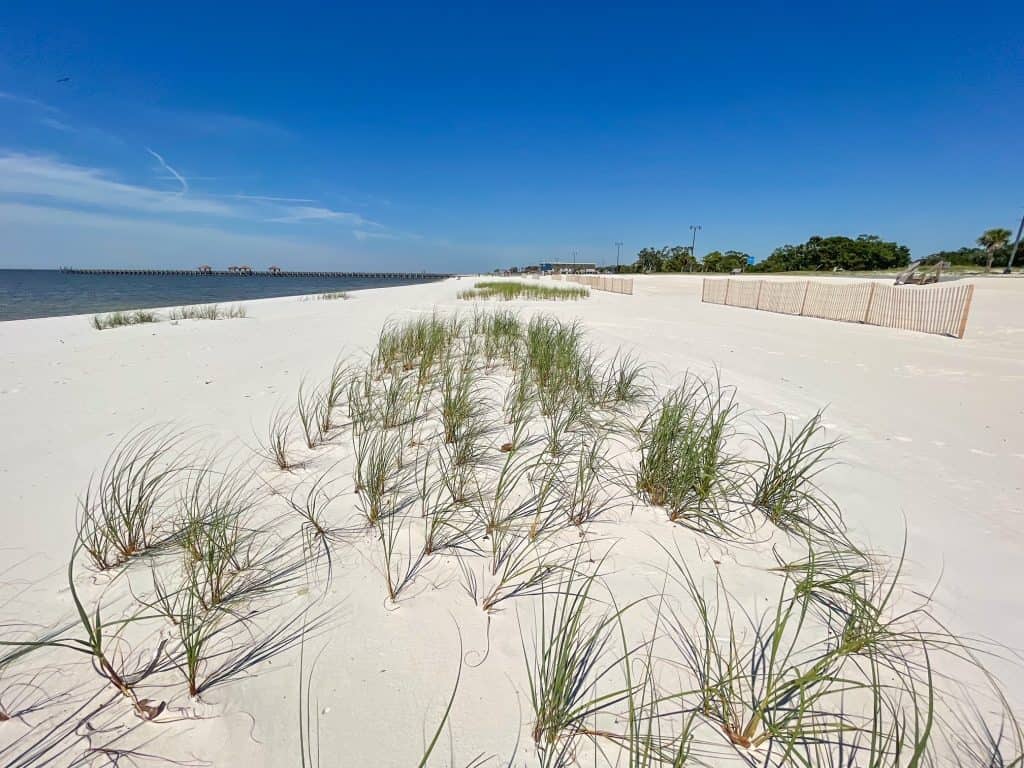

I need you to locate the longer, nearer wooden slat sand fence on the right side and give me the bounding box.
[700,278,974,339]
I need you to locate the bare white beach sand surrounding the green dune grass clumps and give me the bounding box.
[0,275,1024,766]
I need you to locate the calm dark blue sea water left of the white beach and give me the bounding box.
[0,269,438,321]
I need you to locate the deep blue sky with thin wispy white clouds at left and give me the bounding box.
[0,2,1024,269]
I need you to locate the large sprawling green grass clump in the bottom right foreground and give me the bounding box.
[666,542,966,766]
